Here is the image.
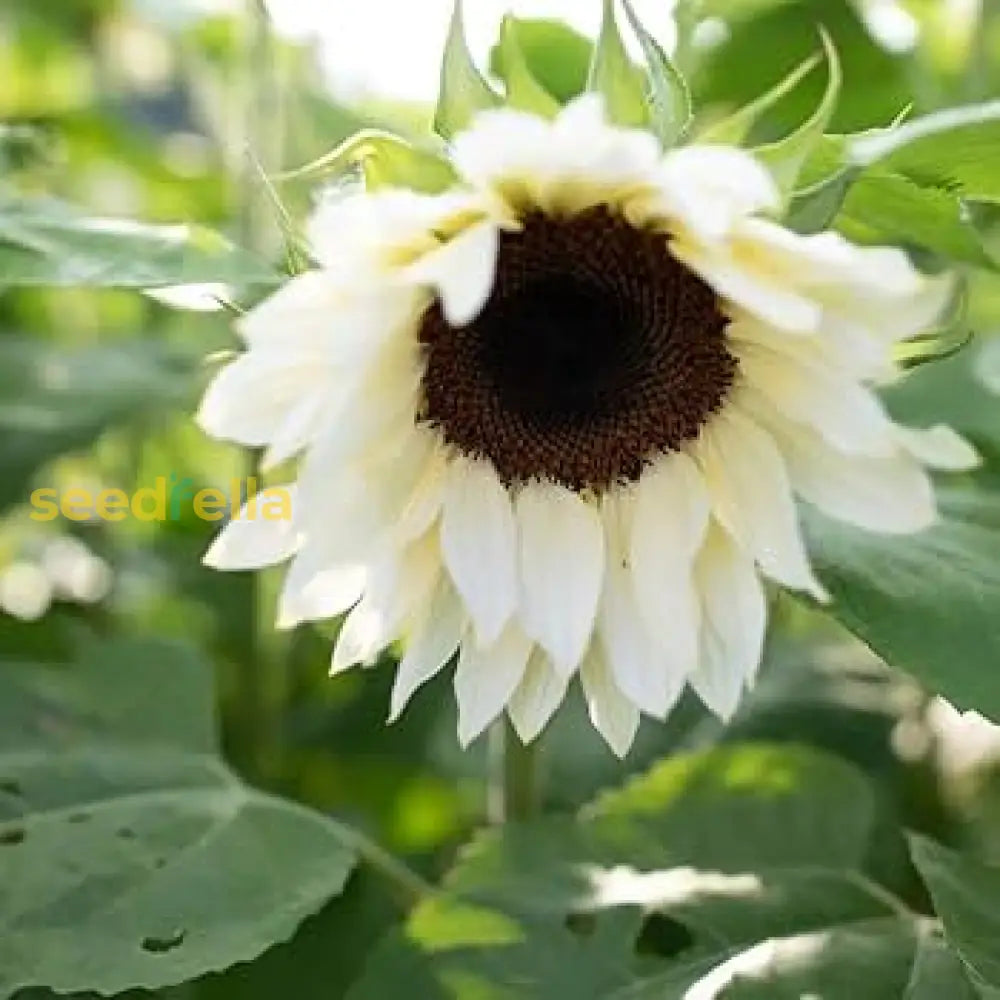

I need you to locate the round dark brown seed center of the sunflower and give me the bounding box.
[420,208,736,490]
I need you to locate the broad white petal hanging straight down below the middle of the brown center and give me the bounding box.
[516,482,604,676]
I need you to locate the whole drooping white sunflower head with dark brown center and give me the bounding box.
[200,95,975,754]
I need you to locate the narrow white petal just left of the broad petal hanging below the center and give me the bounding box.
[441,458,517,645]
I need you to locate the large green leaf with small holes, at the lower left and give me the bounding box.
[0,641,357,997]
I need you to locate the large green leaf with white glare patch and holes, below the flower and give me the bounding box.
[350,745,913,1000]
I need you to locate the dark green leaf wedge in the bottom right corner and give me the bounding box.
[910,836,1000,989]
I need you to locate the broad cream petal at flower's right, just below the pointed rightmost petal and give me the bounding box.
[774,414,937,535]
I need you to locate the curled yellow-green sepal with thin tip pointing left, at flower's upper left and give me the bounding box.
[281,129,458,194]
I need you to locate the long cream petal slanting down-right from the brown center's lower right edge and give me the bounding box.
[698,405,827,600]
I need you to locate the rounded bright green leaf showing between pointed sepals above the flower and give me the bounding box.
[490,15,594,104]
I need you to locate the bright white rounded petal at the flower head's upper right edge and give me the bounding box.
[660,145,780,241]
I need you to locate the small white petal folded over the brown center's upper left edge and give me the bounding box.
[406,221,499,327]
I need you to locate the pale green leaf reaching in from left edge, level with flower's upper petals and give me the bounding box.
[0,197,281,288]
